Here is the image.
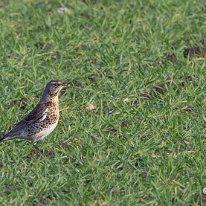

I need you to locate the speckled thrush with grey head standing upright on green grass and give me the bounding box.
[0,80,68,151]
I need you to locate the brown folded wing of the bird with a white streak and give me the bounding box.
[15,104,48,128]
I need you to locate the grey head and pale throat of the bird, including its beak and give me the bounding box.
[40,80,68,103]
